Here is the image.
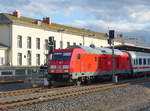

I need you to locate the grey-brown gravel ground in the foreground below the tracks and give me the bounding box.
[4,82,150,111]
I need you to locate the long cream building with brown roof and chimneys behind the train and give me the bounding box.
[0,11,121,66]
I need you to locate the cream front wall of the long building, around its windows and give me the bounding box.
[11,25,122,66]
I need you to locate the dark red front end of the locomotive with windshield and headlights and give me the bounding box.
[48,49,73,81]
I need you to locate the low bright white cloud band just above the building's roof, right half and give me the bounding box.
[68,20,150,32]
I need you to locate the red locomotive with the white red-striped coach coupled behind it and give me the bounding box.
[47,46,150,85]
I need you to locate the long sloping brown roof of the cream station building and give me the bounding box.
[0,13,123,42]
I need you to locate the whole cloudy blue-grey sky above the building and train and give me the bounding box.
[0,0,150,46]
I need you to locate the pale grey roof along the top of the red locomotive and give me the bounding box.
[68,46,123,55]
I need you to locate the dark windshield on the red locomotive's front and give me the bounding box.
[52,52,71,60]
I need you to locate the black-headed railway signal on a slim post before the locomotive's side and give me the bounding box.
[108,30,118,83]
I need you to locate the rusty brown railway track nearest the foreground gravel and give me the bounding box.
[0,79,150,110]
